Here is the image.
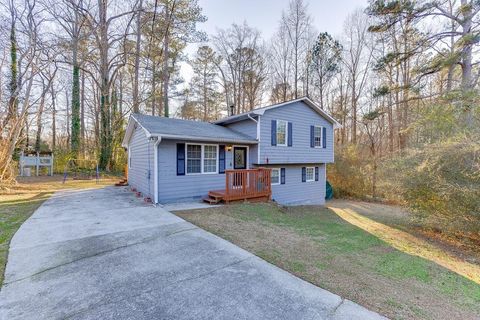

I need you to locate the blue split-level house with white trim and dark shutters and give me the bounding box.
[122,97,339,205]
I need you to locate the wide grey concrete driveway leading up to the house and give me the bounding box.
[0,187,381,320]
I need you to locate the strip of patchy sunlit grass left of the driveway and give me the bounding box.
[0,176,118,287]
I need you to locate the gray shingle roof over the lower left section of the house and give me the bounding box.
[132,113,257,143]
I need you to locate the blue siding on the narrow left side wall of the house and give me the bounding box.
[128,126,154,199]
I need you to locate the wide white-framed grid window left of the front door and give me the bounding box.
[187,144,218,174]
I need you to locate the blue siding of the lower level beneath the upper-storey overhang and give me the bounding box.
[272,164,325,205]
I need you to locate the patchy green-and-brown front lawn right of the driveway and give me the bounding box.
[176,204,480,319]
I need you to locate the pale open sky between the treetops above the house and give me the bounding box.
[176,0,368,111]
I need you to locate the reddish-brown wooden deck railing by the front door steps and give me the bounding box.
[224,168,272,201]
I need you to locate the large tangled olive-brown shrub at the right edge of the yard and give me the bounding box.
[384,135,480,231]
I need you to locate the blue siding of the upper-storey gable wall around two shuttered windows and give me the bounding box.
[258,101,333,164]
